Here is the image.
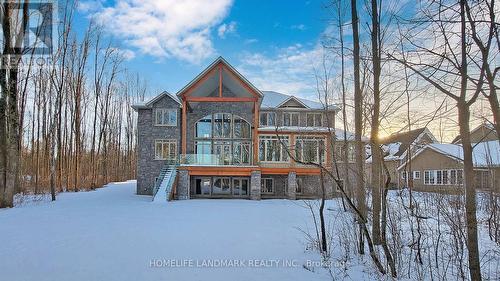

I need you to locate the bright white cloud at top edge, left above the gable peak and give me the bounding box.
[85,0,232,63]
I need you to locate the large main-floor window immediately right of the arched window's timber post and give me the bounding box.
[259,136,289,162]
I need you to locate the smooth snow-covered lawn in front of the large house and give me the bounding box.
[0,181,362,281]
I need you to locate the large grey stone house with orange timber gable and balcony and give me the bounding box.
[133,57,348,199]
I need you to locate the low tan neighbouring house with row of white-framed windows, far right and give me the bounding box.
[398,140,500,191]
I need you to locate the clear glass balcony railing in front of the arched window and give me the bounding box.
[179,154,250,166]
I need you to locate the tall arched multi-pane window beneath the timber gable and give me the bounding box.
[195,113,252,165]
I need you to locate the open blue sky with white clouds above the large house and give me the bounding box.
[77,0,327,100]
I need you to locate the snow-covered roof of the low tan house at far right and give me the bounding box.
[398,140,500,170]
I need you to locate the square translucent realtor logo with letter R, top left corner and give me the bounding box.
[0,0,57,67]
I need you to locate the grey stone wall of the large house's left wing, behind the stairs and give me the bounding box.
[137,95,181,195]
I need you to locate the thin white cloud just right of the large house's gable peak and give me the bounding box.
[238,44,324,99]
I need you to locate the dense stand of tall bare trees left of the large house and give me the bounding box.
[0,1,147,207]
